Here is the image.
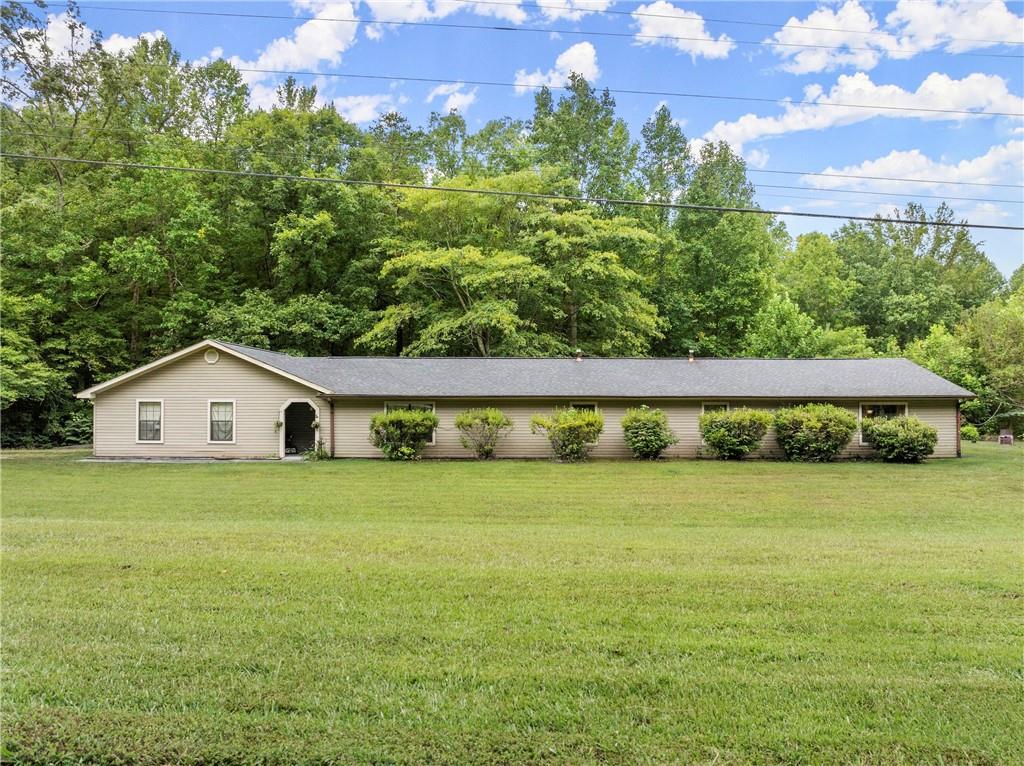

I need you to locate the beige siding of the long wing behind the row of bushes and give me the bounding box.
[334,397,956,459]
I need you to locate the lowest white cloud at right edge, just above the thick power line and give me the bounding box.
[801,140,1024,198]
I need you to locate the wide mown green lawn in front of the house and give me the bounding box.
[2,444,1024,766]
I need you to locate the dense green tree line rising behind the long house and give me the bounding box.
[0,4,1024,445]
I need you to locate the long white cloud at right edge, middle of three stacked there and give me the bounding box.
[703,72,1024,152]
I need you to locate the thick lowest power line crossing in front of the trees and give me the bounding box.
[0,152,1024,231]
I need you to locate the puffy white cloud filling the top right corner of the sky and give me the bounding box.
[765,0,1024,74]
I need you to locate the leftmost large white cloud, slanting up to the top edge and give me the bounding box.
[229,0,357,84]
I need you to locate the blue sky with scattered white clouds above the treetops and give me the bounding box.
[41,0,1024,274]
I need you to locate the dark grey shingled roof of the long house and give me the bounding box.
[217,341,974,399]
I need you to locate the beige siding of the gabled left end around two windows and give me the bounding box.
[93,349,331,458]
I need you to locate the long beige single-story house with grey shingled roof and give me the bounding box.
[78,340,974,458]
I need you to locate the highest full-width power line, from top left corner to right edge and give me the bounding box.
[54,0,1024,58]
